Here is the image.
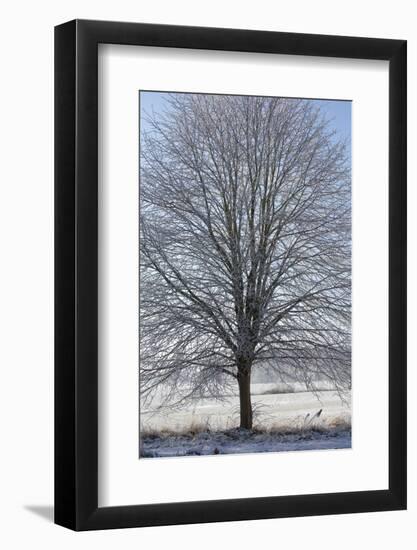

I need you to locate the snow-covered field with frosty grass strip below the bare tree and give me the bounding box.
[140,384,351,457]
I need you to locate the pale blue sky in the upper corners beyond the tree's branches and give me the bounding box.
[140,92,352,144]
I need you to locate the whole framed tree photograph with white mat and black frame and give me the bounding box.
[55,20,406,530]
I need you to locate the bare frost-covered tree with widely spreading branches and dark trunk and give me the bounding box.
[140,94,351,429]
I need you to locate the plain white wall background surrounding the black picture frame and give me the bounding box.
[0,0,417,550]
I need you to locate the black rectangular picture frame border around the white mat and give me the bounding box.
[55,20,406,531]
